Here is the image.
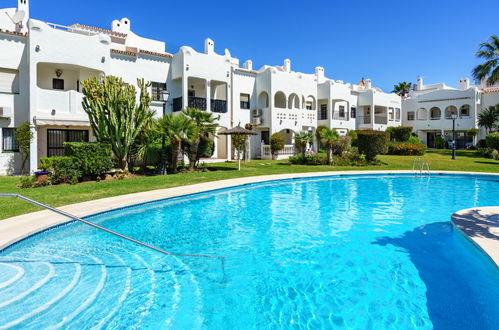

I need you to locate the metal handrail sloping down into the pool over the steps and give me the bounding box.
[0,193,225,267]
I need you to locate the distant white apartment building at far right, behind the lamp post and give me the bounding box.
[402,77,499,148]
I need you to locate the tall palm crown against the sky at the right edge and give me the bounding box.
[472,35,499,86]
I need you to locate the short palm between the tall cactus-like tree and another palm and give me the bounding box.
[158,114,197,173]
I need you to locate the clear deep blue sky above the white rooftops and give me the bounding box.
[10,0,499,91]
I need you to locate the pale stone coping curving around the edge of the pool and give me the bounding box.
[0,170,499,267]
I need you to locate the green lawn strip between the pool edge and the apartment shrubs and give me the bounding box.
[0,150,499,219]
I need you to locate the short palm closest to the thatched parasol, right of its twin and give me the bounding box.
[182,108,220,171]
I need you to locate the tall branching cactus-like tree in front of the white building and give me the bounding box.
[82,76,154,169]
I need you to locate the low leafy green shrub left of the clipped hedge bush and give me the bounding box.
[40,156,82,184]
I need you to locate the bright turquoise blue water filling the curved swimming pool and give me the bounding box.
[0,175,499,329]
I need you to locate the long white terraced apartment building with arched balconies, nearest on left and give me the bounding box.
[0,0,401,174]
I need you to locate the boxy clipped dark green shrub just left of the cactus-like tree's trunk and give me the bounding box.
[64,142,113,178]
